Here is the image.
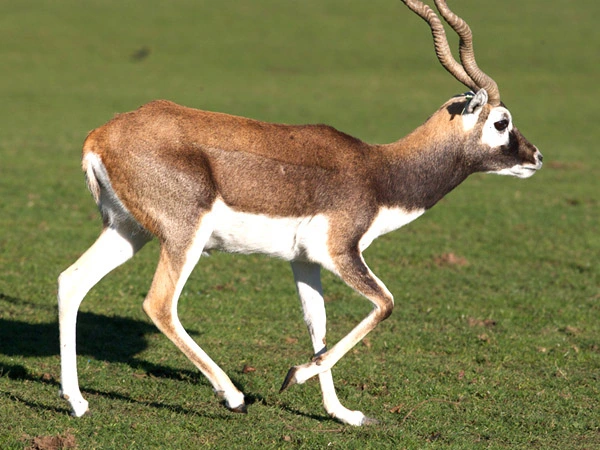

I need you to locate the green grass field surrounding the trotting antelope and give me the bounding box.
[0,0,600,449]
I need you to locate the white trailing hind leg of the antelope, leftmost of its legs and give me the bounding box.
[58,225,150,417]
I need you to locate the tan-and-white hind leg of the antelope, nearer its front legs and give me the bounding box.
[144,214,246,412]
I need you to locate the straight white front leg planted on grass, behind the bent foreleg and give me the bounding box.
[290,261,382,425]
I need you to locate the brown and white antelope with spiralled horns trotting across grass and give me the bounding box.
[58,0,542,426]
